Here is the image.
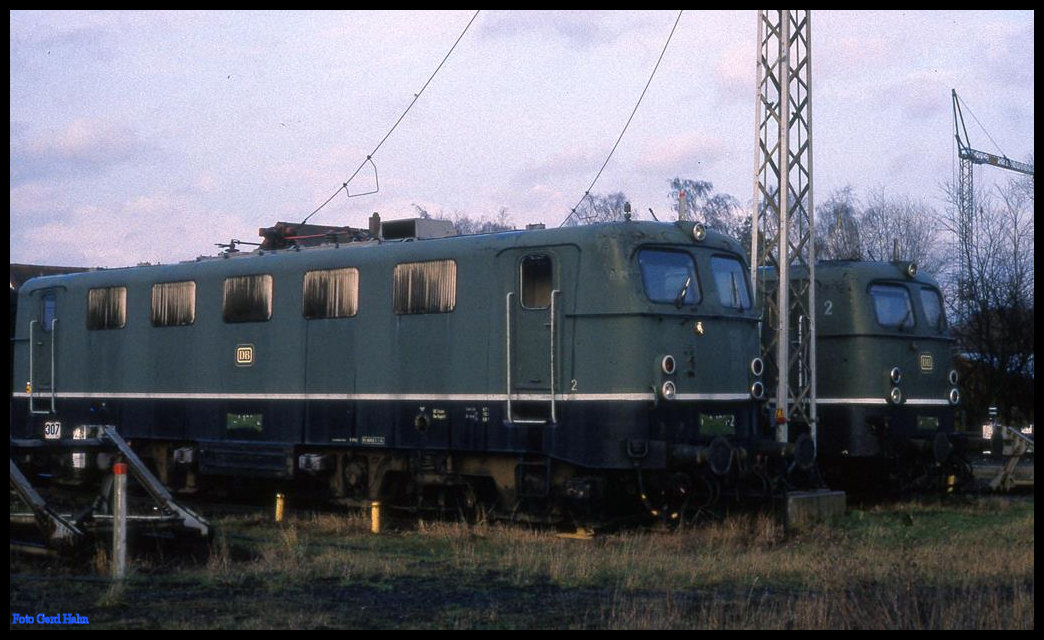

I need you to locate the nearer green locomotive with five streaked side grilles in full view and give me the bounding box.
[11,216,785,519]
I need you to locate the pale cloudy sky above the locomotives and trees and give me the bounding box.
[10,10,1034,266]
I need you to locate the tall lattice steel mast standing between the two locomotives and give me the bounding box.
[751,9,816,443]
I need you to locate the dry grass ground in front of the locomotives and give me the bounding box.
[11,498,1035,629]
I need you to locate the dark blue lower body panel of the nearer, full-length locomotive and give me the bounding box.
[10,398,756,471]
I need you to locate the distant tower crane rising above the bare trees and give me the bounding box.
[950,89,1034,321]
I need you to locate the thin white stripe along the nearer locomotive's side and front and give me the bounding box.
[13,392,750,402]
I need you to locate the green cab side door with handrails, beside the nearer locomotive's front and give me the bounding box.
[505,246,576,424]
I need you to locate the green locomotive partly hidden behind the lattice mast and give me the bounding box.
[762,261,975,493]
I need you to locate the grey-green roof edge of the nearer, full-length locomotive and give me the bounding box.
[23,220,743,291]
